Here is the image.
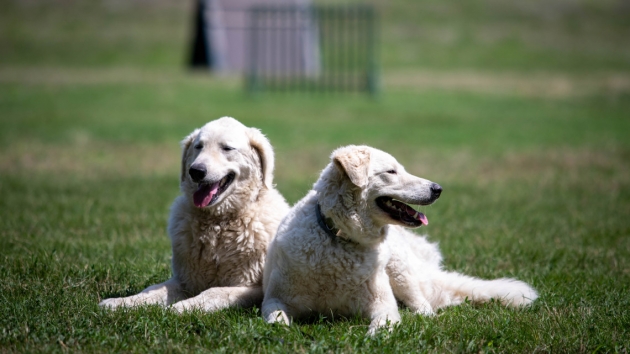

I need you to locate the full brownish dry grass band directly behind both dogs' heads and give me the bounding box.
[0,139,630,193]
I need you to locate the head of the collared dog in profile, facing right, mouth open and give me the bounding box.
[315,145,442,238]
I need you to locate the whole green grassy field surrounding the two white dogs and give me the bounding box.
[0,0,630,353]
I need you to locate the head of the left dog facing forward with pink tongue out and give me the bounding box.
[180,117,274,209]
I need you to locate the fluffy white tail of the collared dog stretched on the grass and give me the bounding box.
[430,272,538,309]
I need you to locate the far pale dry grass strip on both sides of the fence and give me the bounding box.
[0,67,630,98]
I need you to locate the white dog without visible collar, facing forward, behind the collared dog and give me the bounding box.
[100,117,289,312]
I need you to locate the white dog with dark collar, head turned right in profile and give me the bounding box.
[262,146,537,334]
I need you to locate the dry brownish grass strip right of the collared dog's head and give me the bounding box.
[391,147,630,193]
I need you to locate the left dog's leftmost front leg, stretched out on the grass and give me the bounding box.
[99,278,186,309]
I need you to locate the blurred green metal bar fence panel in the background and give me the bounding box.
[245,5,377,94]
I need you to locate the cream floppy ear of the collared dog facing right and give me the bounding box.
[332,145,370,187]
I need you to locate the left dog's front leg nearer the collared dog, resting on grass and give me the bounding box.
[173,286,263,313]
